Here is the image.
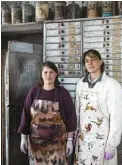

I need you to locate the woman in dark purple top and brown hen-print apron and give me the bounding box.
[18,61,76,165]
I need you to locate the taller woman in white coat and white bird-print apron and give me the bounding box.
[74,49,122,165]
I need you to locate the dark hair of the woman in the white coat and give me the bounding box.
[82,49,105,73]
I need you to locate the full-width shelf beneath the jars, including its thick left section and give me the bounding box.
[1,16,122,36]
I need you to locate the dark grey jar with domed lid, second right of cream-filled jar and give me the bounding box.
[68,1,80,19]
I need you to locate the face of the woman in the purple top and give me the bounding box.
[42,66,57,85]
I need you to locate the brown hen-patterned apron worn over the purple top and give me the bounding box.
[28,89,67,165]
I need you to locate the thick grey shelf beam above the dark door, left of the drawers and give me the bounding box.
[1,22,43,35]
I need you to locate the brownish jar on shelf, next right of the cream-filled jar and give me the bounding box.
[54,1,66,20]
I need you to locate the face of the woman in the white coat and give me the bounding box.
[85,55,102,73]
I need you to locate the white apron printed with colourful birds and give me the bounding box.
[74,88,109,165]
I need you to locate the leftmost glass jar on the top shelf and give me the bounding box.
[1,5,11,24]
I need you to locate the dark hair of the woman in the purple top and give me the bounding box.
[40,61,60,87]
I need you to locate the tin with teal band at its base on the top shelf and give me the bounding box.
[102,1,113,17]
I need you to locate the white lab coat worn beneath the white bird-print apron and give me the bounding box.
[74,72,122,165]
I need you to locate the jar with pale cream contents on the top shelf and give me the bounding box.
[35,1,49,22]
